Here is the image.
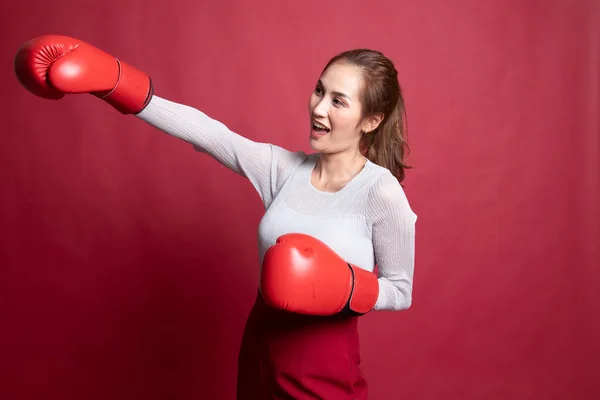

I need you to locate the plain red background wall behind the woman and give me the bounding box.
[0,0,600,400]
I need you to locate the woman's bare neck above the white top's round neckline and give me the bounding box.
[314,152,367,182]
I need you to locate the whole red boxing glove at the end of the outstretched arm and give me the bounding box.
[15,35,153,114]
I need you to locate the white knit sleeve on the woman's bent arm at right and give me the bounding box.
[367,173,417,311]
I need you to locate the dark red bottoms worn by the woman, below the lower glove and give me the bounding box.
[237,295,367,400]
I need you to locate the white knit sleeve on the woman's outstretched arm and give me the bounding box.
[137,96,306,208]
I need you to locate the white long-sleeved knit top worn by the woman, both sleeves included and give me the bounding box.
[137,96,417,310]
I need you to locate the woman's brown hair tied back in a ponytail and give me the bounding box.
[324,49,411,182]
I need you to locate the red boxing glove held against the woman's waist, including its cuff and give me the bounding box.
[260,233,379,316]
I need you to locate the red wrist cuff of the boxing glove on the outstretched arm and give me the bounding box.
[98,59,154,114]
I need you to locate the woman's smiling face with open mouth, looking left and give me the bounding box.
[308,62,365,153]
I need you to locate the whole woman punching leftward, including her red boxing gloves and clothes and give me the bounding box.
[15,35,416,400]
